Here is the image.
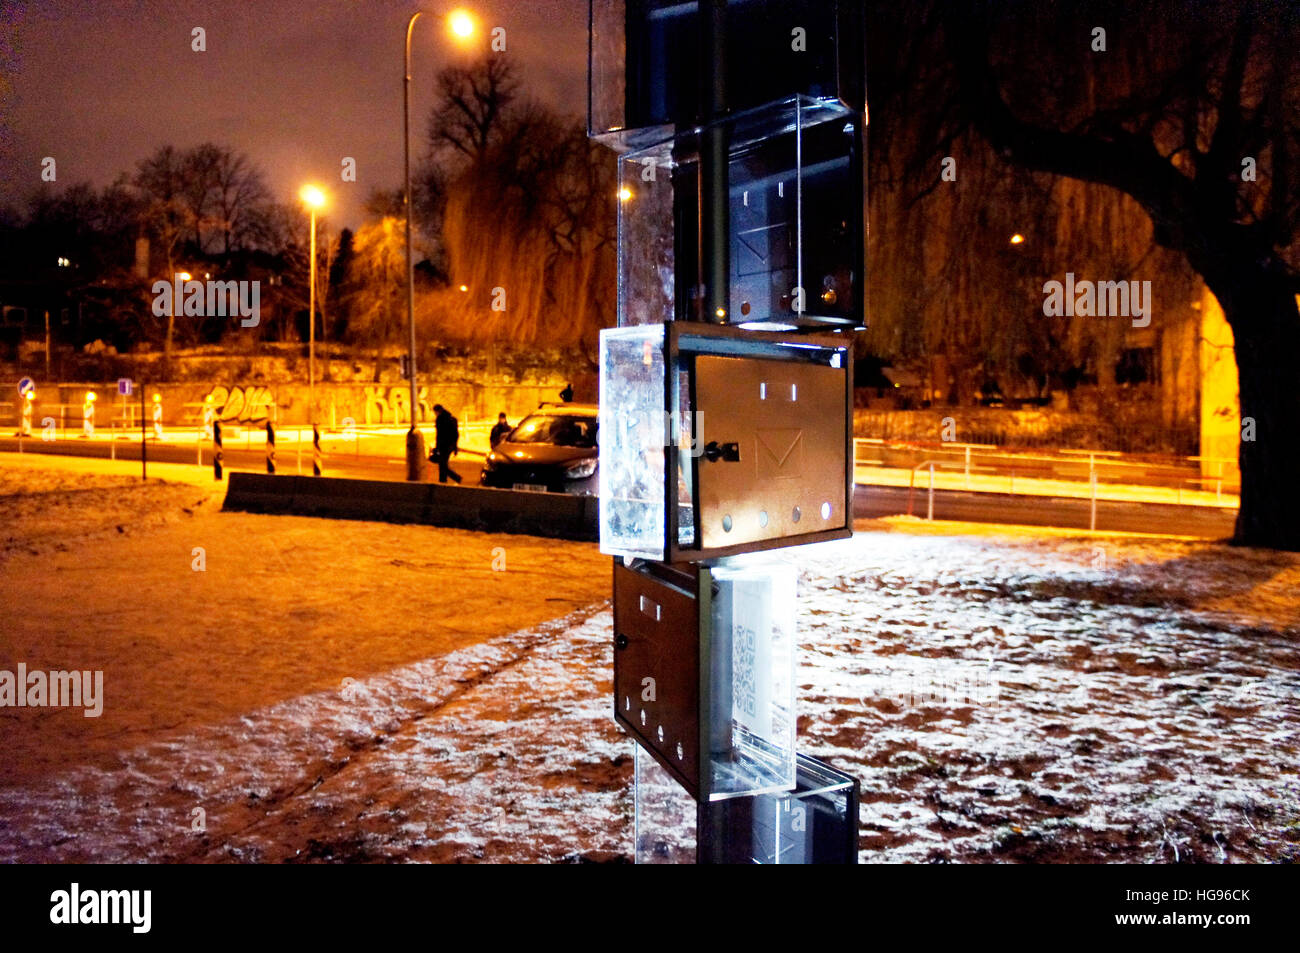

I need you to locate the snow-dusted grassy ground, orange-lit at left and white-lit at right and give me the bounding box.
[0,459,1300,862]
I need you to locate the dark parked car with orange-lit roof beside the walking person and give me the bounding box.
[481,403,599,497]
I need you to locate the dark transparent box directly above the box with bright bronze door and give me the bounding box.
[619,98,866,329]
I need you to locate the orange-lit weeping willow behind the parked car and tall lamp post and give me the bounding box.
[423,53,616,346]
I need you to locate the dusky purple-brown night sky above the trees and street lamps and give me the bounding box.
[0,0,586,228]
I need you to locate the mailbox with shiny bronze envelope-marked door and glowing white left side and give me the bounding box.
[599,321,853,562]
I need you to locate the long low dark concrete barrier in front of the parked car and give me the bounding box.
[224,472,599,541]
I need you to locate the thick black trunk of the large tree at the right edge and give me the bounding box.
[1210,268,1300,551]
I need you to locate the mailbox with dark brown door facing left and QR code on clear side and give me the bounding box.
[614,560,796,801]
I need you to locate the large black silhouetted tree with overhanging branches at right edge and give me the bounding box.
[904,0,1300,550]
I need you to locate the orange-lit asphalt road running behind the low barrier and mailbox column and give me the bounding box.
[0,437,1236,540]
